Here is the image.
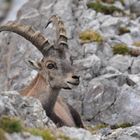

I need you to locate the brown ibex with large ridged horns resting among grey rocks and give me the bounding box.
[0,15,84,127]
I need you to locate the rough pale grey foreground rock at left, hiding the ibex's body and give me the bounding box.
[0,91,55,128]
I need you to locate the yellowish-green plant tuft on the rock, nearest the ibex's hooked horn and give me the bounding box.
[79,30,103,43]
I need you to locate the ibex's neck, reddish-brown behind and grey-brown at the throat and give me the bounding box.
[21,74,60,116]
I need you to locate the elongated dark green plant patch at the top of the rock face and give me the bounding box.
[87,2,123,14]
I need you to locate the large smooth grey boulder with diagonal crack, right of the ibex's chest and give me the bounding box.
[83,75,140,125]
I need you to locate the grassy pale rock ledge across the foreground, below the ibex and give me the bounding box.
[0,91,140,140]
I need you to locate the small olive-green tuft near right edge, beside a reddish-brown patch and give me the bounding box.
[113,44,129,55]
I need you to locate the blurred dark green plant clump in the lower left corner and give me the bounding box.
[0,116,22,133]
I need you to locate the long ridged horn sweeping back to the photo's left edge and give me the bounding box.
[0,22,51,55]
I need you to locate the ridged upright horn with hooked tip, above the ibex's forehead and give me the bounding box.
[45,15,68,47]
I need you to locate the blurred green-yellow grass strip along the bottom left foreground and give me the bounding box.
[0,116,70,140]
